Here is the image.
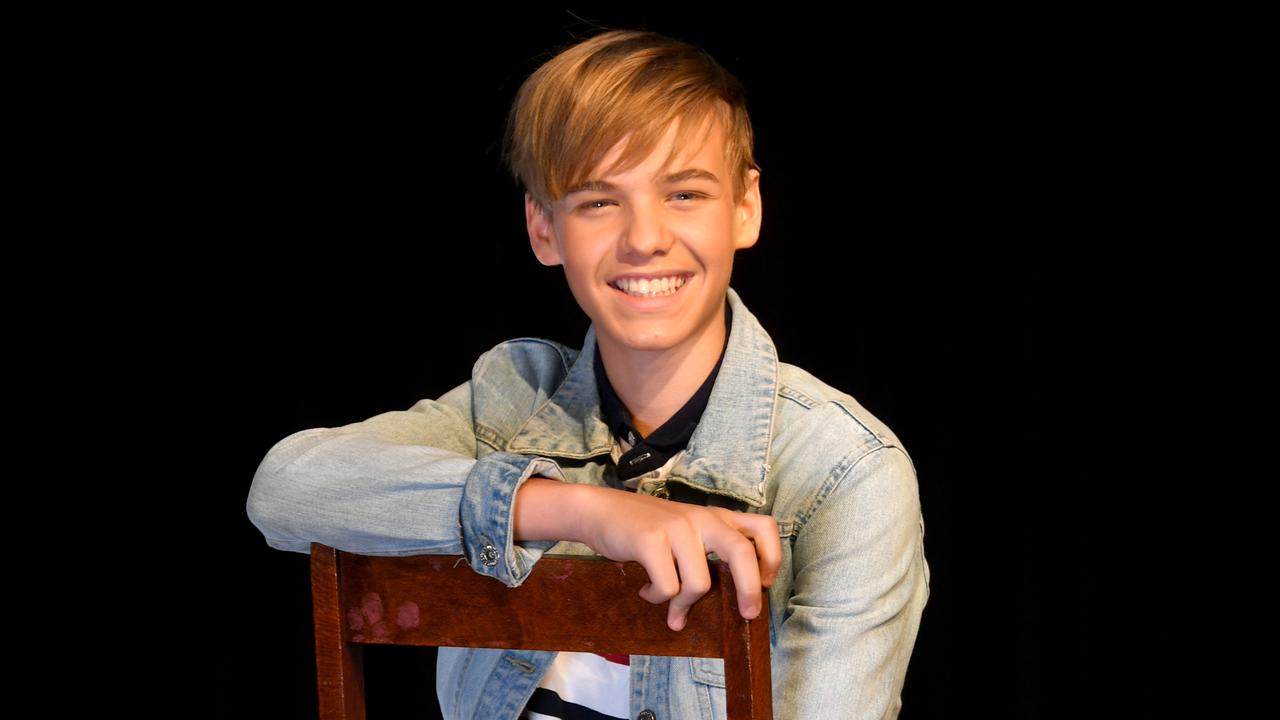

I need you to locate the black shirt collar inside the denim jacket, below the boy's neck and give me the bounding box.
[595,302,733,479]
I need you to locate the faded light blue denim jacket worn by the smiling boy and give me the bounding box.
[247,288,929,720]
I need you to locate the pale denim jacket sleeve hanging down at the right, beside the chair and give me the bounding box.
[773,446,929,720]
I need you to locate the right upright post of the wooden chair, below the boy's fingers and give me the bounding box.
[718,562,773,720]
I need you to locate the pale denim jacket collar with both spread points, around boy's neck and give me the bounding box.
[507,287,778,507]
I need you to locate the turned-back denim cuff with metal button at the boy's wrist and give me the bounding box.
[458,452,567,588]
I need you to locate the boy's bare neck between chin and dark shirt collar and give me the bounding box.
[596,299,728,437]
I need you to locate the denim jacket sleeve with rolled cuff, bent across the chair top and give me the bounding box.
[246,356,564,587]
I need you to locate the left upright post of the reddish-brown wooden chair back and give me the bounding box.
[311,543,365,720]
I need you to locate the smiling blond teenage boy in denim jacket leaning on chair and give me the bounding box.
[247,25,929,719]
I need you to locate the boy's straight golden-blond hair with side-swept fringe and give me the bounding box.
[502,29,759,217]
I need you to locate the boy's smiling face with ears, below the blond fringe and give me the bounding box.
[525,119,760,357]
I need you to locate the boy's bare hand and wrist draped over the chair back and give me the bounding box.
[573,486,782,630]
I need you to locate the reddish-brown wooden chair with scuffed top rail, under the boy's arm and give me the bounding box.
[311,543,773,720]
